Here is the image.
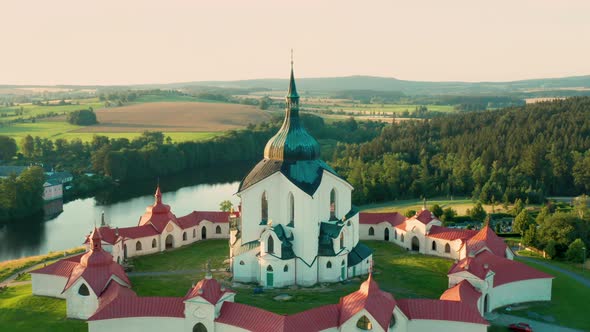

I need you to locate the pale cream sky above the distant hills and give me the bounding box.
[0,0,590,84]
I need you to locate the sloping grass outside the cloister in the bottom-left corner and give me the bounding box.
[0,285,88,332]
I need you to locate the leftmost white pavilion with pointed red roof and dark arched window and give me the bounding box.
[31,228,131,319]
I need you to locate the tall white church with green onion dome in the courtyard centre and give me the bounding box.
[230,68,372,287]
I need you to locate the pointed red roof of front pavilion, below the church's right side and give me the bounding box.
[339,274,396,331]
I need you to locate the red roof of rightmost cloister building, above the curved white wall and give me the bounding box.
[449,250,553,287]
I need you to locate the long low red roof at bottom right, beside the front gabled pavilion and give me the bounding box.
[397,299,490,325]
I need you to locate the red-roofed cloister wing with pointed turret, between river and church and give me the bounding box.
[86,185,238,262]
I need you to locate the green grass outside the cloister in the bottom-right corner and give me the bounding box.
[510,258,590,331]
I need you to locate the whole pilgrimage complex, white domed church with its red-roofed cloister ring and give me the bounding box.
[31,63,553,332]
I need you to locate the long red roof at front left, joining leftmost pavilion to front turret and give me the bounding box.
[88,282,184,321]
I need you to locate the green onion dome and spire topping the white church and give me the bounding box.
[264,68,320,161]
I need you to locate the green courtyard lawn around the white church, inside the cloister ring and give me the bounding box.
[131,240,452,314]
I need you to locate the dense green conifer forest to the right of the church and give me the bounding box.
[331,97,590,204]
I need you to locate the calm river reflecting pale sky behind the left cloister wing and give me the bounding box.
[0,164,251,262]
